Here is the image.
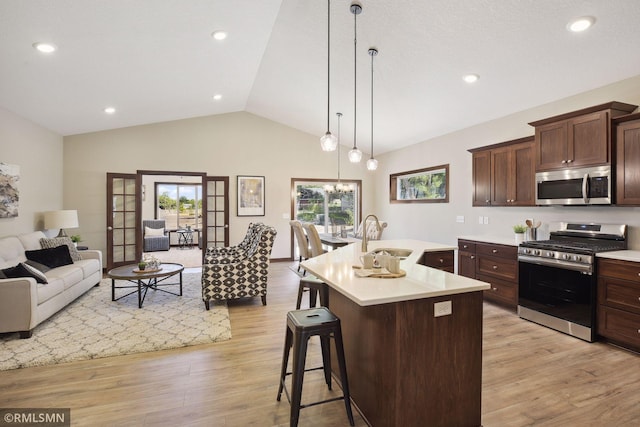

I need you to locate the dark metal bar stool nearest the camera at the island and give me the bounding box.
[277,307,354,427]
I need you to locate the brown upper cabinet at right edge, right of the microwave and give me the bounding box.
[614,113,640,206]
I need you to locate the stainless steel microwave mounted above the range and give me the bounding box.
[536,165,612,205]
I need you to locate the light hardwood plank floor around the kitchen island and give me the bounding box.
[0,263,640,427]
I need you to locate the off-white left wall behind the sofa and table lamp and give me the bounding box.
[0,108,63,236]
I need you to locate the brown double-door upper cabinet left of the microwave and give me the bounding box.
[469,137,535,206]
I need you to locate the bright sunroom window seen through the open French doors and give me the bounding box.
[155,183,202,229]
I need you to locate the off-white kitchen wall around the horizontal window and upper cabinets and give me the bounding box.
[374,76,640,249]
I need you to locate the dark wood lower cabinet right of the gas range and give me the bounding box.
[598,258,640,351]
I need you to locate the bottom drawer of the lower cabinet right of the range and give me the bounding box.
[598,305,640,349]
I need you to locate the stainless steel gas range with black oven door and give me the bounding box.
[518,223,627,342]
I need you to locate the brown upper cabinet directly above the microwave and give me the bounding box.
[529,101,637,171]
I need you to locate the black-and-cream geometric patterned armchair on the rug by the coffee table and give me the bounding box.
[202,225,277,310]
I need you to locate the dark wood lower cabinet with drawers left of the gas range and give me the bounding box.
[458,239,518,309]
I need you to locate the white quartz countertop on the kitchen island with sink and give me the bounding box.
[302,240,490,306]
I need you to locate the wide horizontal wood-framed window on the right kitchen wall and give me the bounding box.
[389,164,449,203]
